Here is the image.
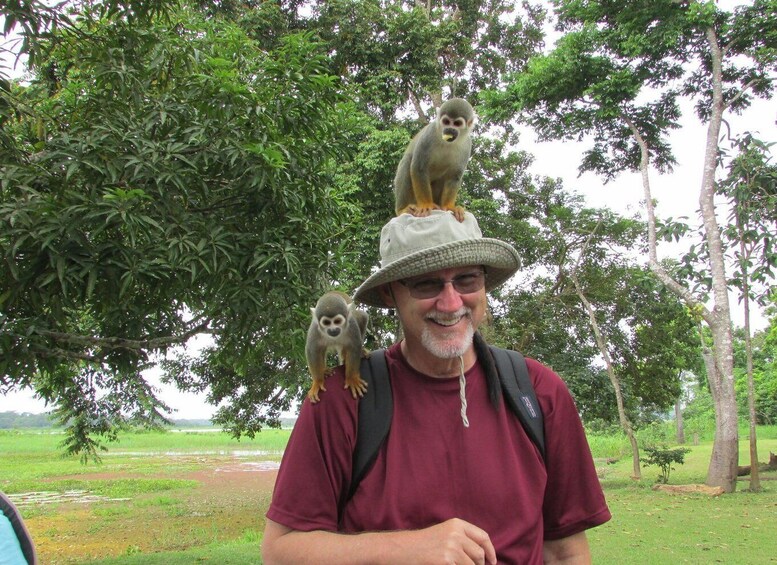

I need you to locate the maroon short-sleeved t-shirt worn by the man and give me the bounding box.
[267,345,610,564]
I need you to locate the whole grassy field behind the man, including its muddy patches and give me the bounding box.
[0,427,777,565]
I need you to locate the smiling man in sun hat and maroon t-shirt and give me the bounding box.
[262,211,610,565]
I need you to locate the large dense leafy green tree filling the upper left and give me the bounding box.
[0,0,542,454]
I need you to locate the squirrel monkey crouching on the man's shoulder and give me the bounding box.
[305,290,369,403]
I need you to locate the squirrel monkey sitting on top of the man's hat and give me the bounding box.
[394,98,475,222]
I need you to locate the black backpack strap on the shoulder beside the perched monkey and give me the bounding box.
[345,349,394,502]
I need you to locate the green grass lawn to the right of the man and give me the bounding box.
[588,434,777,565]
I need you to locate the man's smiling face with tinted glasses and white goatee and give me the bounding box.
[384,266,486,359]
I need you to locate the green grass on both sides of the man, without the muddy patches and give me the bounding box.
[0,426,777,565]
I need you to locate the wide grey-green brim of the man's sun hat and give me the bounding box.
[354,237,521,308]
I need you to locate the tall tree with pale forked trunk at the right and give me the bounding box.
[485,0,777,491]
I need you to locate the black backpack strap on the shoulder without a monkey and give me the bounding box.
[489,345,545,459]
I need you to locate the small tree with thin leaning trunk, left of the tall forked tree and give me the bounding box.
[540,211,695,479]
